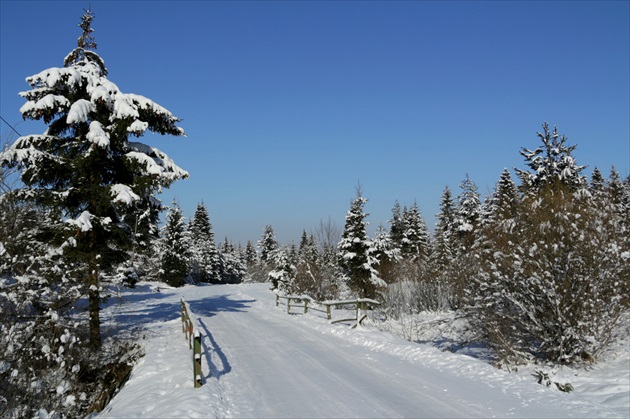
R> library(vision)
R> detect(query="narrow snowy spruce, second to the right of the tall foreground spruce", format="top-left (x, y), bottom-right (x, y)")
top-left (189, 202), bottom-right (220, 282)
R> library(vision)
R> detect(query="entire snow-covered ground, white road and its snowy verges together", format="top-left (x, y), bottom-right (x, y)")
top-left (96, 283), bottom-right (630, 418)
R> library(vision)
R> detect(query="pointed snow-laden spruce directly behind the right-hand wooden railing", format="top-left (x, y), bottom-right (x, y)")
top-left (337, 187), bottom-right (387, 298)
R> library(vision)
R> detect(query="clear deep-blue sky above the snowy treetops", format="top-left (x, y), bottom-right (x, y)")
top-left (0, 0), bottom-right (630, 245)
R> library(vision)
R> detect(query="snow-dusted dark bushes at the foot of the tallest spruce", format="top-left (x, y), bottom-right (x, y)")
top-left (0, 274), bottom-right (139, 418)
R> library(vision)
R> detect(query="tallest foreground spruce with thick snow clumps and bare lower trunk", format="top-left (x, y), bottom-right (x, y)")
top-left (0, 10), bottom-right (188, 348)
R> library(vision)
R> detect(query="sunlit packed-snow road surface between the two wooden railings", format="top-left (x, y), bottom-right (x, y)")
top-left (202, 296), bottom-right (478, 417)
